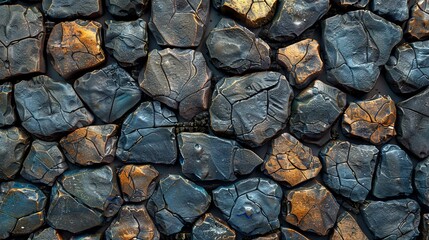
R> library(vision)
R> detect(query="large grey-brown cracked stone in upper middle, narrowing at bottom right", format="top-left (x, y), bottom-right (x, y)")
top-left (139, 48), bottom-right (211, 120)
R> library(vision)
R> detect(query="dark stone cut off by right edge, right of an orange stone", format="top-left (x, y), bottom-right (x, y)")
top-left (396, 88), bottom-right (429, 158)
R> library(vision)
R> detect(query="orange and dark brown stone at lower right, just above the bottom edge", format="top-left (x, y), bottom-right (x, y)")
top-left (284, 182), bottom-right (339, 236)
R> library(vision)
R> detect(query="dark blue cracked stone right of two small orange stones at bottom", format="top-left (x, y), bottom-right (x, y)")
top-left (147, 175), bottom-right (211, 235)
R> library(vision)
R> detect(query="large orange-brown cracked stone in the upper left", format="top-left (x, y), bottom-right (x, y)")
top-left (47, 19), bottom-right (106, 79)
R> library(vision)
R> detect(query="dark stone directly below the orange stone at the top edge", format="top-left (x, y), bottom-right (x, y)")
top-left (206, 18), bottom-right (271, 74)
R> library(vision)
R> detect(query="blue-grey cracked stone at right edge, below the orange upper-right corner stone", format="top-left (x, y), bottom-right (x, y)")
top-left (385, 41), bottom-right (429, 94)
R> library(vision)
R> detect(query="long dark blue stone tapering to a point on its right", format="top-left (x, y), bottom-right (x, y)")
top-left (177, 132), bottom-right (263, 181)
